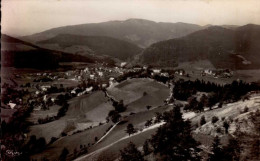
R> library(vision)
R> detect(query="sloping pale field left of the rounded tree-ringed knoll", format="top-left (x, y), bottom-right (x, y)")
top-left (29, 91), bottom-right (113, 142)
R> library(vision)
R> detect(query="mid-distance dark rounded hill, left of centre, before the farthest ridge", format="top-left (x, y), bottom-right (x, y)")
top-left (38, 34), bottom-right (141, 60)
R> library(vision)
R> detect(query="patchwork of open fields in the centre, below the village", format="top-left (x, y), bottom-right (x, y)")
top-left (30, 79), bottom-right (170, 159)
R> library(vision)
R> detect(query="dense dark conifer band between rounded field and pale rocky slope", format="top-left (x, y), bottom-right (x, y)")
top-left (173, 80), bottom-right (260, 112)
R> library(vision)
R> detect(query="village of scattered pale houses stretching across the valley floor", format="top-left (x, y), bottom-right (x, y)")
top-left (2, 62), bottom-right (236, 118)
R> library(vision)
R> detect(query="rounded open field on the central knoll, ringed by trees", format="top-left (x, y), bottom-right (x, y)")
top-left (108, 78), bottom-right (170, 112)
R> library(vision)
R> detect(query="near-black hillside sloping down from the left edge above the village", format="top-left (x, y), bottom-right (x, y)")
top-left (1, 34), bottom-right (100, 69)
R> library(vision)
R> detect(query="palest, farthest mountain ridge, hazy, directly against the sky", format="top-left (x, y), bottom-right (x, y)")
top-left (22, 19), bottom-right (202, 47)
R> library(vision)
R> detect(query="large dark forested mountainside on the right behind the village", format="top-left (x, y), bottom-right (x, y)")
top-left (141, 25), bottom-right (260, 69)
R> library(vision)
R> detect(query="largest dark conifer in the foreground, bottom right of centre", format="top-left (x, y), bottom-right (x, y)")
top-left (150, 107), bottom-right (200, 161)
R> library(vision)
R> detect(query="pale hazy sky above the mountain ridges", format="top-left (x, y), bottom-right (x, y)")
top-left (1, 0), bottom-right (260, 36)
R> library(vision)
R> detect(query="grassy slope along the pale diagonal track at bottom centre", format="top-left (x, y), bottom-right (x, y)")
top-left (76, 106), bottom-right (171, 160)
